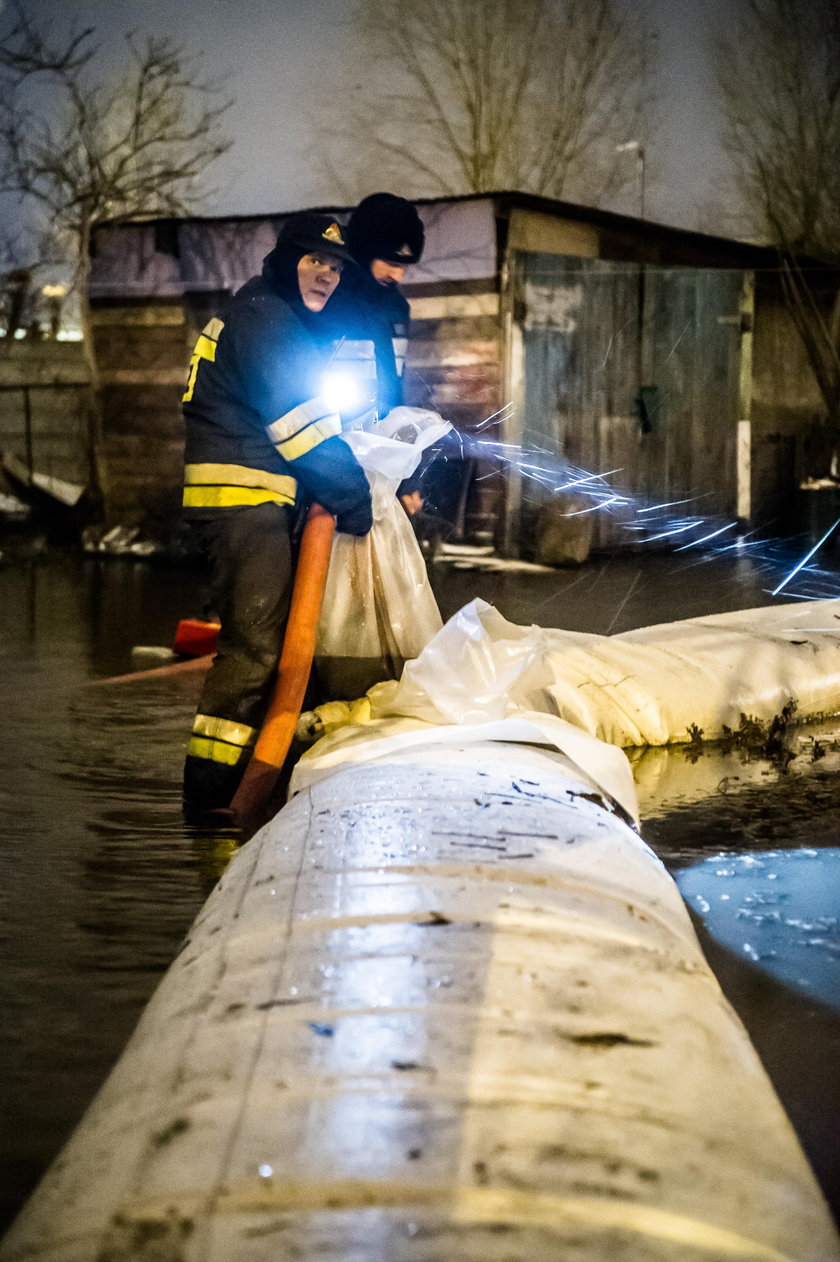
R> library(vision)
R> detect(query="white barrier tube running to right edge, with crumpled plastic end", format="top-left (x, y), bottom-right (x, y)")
top-left (370, 599), bottom-right (840, 747)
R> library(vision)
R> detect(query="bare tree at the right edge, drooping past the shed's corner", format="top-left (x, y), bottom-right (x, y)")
top-left (716, 0), bottom-right (840, 440)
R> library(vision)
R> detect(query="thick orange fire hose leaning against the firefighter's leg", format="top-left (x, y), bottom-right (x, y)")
top-left (230, 504), bottom-right (335, 839)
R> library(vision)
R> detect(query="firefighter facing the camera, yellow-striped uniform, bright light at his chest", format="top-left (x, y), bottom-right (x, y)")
top-left (183, 212), bottom-right (372, 813)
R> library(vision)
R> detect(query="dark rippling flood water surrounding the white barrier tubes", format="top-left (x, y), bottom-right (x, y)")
top-left (0, 548), bottom-right (840, 1225)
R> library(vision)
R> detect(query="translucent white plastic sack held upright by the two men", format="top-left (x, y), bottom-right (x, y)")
top-left (315, 408), bottom-right (452, 699)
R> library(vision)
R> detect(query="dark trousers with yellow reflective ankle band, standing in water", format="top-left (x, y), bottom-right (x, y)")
top-left (184, 504), bottom-right (294, 810)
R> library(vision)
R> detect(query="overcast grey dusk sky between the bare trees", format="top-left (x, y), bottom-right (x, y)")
top-left (6, 0), bottom-right (738, 231)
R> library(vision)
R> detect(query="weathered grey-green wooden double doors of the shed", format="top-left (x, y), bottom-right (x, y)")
top-left (508, 252), bottom-right (743, 555)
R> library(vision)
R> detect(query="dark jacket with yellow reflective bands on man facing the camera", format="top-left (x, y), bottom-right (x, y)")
top-left (183, 255), bottom-right (371, 534)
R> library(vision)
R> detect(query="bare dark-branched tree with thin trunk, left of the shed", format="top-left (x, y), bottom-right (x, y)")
top-left (0, 0), bottom-right (230, 507)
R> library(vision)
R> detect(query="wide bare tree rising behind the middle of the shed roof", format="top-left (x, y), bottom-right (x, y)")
top-left (310, 0), bottom-right (650, 203)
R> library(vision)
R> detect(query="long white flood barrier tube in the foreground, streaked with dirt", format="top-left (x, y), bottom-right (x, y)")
top-left (0, 742), bottom-right (840, 1262)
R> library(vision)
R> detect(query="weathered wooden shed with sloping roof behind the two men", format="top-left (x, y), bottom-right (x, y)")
top-left (91, 193), bottom-right (825, 557)
